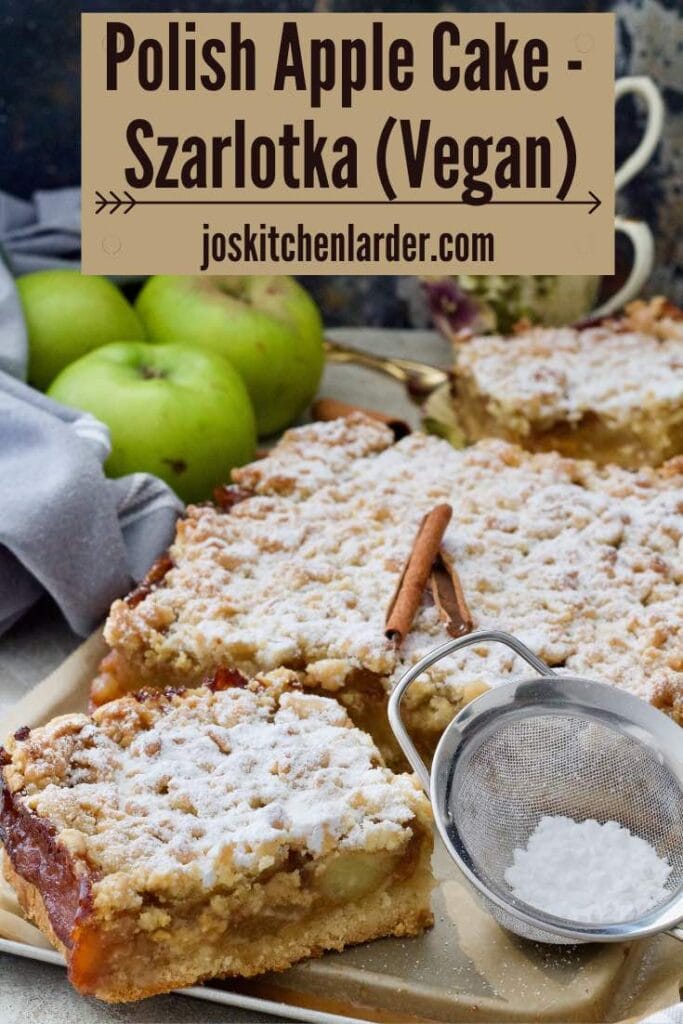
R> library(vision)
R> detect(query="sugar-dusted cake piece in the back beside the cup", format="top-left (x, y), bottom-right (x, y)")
top-left (453, 299), bottom-right (683, 469)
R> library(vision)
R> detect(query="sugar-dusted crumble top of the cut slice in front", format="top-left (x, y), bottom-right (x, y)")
top-left (11, 672), bottom-right (427, 894)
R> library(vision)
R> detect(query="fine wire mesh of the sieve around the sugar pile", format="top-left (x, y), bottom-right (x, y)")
top-left (447, 708), bottom-right (683, 942)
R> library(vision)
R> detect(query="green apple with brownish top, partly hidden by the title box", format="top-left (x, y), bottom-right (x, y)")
top-left (135, 275), bottom-right (325, 435)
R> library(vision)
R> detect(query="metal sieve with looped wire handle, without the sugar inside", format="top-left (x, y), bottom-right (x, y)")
top-left (389, 631), bottom-right (683, 943)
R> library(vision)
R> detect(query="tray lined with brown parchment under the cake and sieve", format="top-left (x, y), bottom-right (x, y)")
top-left (0, 633), bottom-right (683, 1024)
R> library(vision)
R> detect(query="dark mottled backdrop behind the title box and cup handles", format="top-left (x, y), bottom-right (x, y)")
top-left (0, 0), bottom-right (683, 325)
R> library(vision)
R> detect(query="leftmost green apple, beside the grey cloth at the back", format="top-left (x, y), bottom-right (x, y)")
top-left (16, 270), bottom-right (144, 391)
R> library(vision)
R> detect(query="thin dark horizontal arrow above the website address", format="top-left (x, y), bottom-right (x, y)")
top-left (95, 188), bottom-right (602, 216)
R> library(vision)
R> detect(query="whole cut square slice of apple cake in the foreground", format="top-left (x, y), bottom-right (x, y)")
top-left (0, 670), bottom-right (432, 1001)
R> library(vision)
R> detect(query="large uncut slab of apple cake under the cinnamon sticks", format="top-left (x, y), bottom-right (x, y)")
top-left (92, 415), bottom-right (683, 758)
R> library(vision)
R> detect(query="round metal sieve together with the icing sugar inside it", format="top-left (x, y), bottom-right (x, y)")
top-left (389, 631), bottom-right (683, 944)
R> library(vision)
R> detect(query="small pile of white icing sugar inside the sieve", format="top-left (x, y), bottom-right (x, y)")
top-left (505, 815), bottom-right (672, 925)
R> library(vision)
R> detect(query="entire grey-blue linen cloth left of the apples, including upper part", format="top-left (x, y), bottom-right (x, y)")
top-left (0, 189), bottom-right (182, 636)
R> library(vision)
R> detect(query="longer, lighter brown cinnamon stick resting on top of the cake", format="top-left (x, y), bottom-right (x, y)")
top-left (384, 504), bottom-right (453, 645)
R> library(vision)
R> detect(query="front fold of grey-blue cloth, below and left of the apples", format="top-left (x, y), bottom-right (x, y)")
top-left (0, 373), bottom-right (182, 636)
